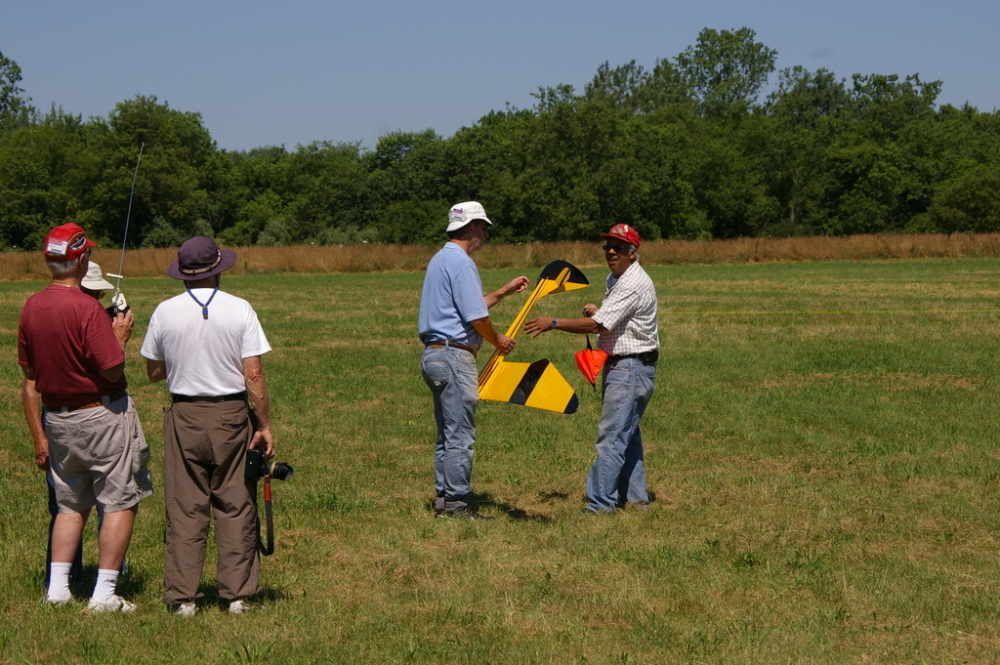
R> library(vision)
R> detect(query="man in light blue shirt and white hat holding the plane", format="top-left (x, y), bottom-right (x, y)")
top-left (418, 201), bottom-right (529, 519)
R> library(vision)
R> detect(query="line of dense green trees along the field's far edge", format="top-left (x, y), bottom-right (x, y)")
top-left (0, 27), bottom-right (1000, 250)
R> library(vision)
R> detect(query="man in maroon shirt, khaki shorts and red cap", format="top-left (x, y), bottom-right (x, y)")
top-left (17, 224), bottom-right (153, 612)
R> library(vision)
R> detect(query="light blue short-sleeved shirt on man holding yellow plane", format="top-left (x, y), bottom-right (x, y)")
top-left (417, 241), bottom-right (489, 349)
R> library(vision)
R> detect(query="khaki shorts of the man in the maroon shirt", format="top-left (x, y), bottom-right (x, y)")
top-left (45, 395), bottom-right (153, 513)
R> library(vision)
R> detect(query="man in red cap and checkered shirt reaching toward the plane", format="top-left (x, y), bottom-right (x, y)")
top-left (524, 224), bottom-right (660, 513)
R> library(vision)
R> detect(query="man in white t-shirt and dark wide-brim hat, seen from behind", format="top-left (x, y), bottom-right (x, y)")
top-left (142, 236), bottom-right (274, 617)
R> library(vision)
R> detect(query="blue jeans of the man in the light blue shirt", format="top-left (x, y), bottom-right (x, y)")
top-left (420, 346), bottom-right (479, 510)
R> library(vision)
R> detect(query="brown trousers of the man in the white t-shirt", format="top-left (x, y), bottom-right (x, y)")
top-left (163, 401), bottom-right (260, 605)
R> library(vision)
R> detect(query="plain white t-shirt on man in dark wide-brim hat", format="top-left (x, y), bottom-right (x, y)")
top-left (141, 289), bottom-right (271, 397)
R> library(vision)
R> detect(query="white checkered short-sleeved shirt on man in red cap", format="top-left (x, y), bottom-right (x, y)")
top-left (592, 263), bottom-right (660, 356)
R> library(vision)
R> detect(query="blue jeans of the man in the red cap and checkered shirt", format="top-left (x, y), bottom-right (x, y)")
top-left (587, 358), bottom-right (656, 513)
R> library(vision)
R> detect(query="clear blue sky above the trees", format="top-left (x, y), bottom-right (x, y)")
top-left (0, 0), bottom-right (1000, 150)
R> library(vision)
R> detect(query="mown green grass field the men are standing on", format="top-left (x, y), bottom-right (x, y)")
top-left (0, 257), bottom-right (1000, 665)
